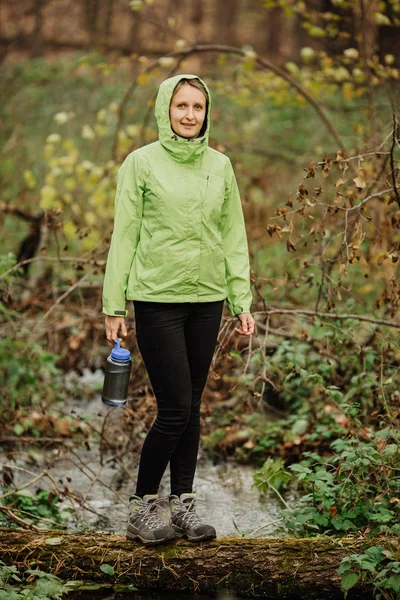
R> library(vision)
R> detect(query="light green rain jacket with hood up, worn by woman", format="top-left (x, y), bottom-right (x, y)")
top-left (103, 75), bottom-right (252, 316)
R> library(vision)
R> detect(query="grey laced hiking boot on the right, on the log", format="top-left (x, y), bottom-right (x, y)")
top-left (169, 493), bottom-right (217, 542)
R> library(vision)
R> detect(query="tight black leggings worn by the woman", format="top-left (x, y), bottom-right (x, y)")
top-left (133, 300), bottom-right (224, 497)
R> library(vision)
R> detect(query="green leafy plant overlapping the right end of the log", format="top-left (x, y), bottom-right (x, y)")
top-left (338, 546), bottom-right (400, 600)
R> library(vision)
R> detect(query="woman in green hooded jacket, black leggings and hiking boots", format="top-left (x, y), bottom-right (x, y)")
top-left (103, 75), bottom-right (254, 544)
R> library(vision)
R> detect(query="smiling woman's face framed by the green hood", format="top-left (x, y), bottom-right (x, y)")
top-left (169, 83), bottom-right (206, 138)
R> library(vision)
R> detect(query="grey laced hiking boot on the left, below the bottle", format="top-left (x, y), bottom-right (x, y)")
top-left (126, 494), bottom-right (176, 546)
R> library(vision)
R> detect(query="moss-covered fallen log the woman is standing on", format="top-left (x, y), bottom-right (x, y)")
top-left (0, 528), bottom-right (400, 600)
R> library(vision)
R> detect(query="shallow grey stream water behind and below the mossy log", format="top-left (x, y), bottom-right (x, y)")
top-left (3, 371), bottom-right (290, 600)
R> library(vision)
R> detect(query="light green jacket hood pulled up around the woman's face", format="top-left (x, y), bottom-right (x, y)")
top-left (155, 74), bottom-right (211, 163)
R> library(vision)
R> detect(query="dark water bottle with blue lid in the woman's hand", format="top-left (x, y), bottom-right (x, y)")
top-left (101, 338), bottom-right (132, 407)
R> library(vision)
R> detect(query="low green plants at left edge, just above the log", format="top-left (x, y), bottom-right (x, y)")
top-left (1, 488), bottom-right (74, 529)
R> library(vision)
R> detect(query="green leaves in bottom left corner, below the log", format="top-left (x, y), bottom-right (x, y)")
top-left (0, 560), bottom-right (68, 600)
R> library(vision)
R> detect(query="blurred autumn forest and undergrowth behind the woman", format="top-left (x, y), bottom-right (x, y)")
top-left (0, 0), bottom-right (400, 597)
